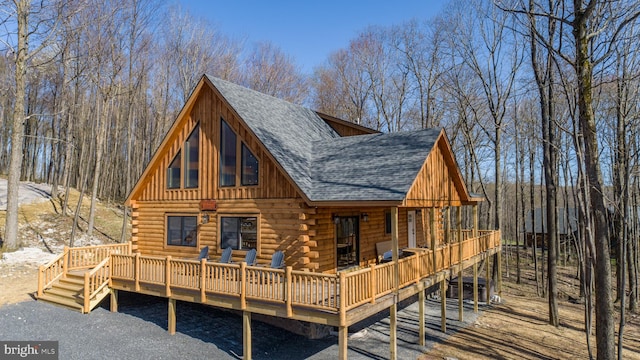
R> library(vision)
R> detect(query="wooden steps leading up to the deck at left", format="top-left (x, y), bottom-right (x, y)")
top-left (38, 270), bottom-right (111, 313)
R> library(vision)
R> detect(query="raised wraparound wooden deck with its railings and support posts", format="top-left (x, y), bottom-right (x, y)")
top-left (38, 230), bottom-right (501, 356)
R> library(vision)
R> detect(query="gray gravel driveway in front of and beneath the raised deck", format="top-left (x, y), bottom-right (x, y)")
top-left (0, 291), bottom-right (477, 360)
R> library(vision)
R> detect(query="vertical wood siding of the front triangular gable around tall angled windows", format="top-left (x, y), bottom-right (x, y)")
top-left (131, 86), bottom-right (299, 202)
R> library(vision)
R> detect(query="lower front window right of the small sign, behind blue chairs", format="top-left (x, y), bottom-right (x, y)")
top-left (220, 216), bottom-right (258, 250)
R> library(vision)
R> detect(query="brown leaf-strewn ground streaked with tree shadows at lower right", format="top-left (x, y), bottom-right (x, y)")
top-left (421, 262), bottom-right (640, 360)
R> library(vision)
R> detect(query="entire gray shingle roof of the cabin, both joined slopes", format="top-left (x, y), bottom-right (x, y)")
top-left (207, 76), bottom-right (440, 201)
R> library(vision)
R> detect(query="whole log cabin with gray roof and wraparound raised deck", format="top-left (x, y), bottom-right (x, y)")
top-left (38, 75), bottom-right (500, 358)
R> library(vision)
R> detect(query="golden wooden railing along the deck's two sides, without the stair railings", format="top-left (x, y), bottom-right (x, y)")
top-left (110, 231), bottom-right (500, 316)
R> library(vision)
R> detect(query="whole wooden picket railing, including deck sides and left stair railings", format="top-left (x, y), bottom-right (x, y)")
top-left (38, 231), bottom-right (500, 322)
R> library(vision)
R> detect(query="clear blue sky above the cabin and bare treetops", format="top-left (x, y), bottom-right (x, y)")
top-left (178, 0), bottom-right (448, 73)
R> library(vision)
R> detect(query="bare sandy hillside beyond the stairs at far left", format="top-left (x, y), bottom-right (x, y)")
top-left (0, 179), bottom-right (130, 306)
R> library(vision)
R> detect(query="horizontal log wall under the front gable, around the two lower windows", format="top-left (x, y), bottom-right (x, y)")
top-left (132, 199), bottom-right (319, 269)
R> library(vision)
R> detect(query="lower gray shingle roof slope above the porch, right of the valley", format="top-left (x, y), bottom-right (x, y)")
top-left (312, 129), bottom-right (440, 201)
